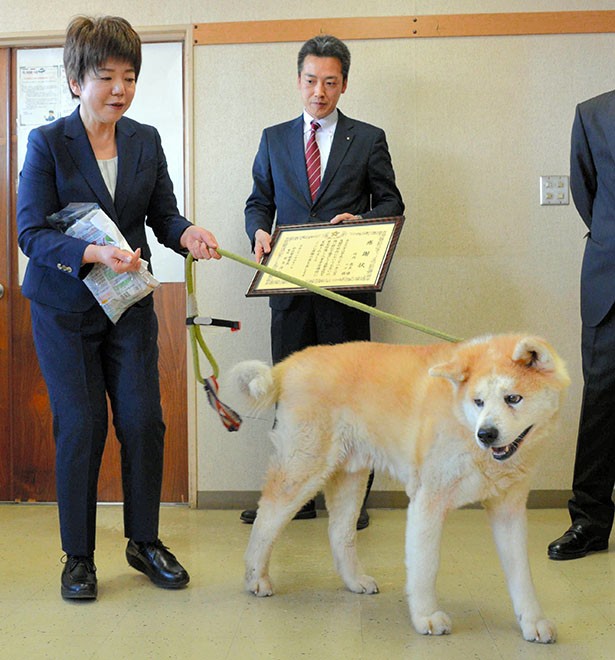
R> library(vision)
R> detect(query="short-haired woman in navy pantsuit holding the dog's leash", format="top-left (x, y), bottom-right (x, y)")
top-left (17, 17), bottom-right (219, 599)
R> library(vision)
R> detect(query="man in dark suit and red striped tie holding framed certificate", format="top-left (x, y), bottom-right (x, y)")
top-left (241, 35), bottom-right (404, 529)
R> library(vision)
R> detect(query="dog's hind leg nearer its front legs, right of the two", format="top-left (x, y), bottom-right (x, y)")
top-left (324, 470), bottom-right (378, 594)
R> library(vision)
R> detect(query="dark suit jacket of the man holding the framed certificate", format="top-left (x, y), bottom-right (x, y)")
top-left (245, 110), bottom-right (404, 309)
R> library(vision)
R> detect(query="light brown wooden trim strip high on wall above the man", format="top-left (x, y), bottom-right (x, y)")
top-left (193, 10), bottom-right (615, 46)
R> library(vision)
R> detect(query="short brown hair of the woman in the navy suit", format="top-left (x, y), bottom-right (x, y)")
top-left (64, 16), bottom-right (141, 98)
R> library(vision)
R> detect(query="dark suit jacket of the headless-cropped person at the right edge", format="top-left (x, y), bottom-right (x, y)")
top-left (570, 91), bottom-right (615, 327)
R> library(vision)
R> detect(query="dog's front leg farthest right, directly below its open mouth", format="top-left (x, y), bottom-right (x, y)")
top-left (485, 499), bottom-right (557, 644)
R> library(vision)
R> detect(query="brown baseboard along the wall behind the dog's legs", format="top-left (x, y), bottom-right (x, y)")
top-left (197, 490), bottom-right (572, 509)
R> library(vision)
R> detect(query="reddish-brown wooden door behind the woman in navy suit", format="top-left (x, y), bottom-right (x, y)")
top-left (0, 45), bottom-right (188, 502)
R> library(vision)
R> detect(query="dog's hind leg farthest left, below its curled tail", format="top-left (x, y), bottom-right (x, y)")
top-left (245, 458), bottom-right (325, 596)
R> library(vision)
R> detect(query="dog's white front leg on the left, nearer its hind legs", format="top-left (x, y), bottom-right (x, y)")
top-left (406, 488), bottom-right (452, 635)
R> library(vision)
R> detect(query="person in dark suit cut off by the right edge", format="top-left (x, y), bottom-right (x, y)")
top-left (548, 92), bottom-right (615, 559)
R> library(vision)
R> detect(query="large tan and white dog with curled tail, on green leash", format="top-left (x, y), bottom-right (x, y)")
top-left (231, 335), bottom-right (569, 642)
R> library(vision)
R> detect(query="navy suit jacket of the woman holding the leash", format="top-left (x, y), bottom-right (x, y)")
top-left (17, 108), bottom-right (190, 312)
